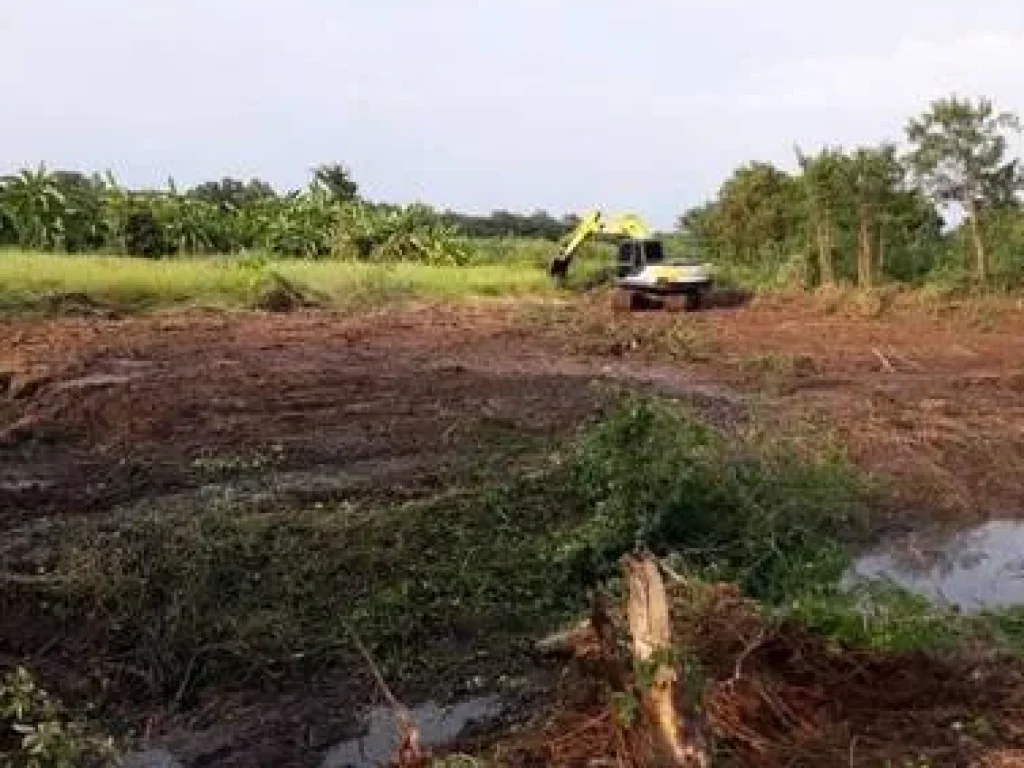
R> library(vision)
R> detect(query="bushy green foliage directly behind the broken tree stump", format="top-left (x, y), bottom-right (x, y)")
top-left (563, 398), bottom-right (862, 599)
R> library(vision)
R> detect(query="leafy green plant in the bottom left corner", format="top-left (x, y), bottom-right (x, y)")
top-left (0, 667), bottom-right (117, 768)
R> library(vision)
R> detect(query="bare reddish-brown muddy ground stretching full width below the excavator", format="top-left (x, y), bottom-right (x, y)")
top-left (0, 300), bottom-right (1024, 765)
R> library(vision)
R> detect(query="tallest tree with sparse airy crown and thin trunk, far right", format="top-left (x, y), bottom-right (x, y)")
top-left (906, 95), bottom-right (1024, 282)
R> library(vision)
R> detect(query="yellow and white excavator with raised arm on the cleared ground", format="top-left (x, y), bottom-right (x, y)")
top-left (549, 211), bottom-right (712, 311)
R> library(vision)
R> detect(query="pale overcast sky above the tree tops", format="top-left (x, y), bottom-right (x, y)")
top-left (0, 0), bottom-right (1024, 225)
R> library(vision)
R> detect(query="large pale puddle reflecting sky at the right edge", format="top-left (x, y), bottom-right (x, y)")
top-left (855, 520), bottom-right (1024, 612)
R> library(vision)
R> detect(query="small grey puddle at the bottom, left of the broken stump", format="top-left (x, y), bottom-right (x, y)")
top-left (323, 696), bottom-right (504, 768)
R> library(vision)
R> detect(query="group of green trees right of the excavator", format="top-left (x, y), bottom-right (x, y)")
top-left (679, 95), bottom-right (1024, 287)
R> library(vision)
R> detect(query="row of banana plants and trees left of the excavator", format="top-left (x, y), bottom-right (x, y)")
top-left (0, 164), bottom-right (575, 258)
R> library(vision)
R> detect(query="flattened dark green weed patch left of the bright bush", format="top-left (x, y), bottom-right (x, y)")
top-left (10, 467), bottom-right (593, 702)
